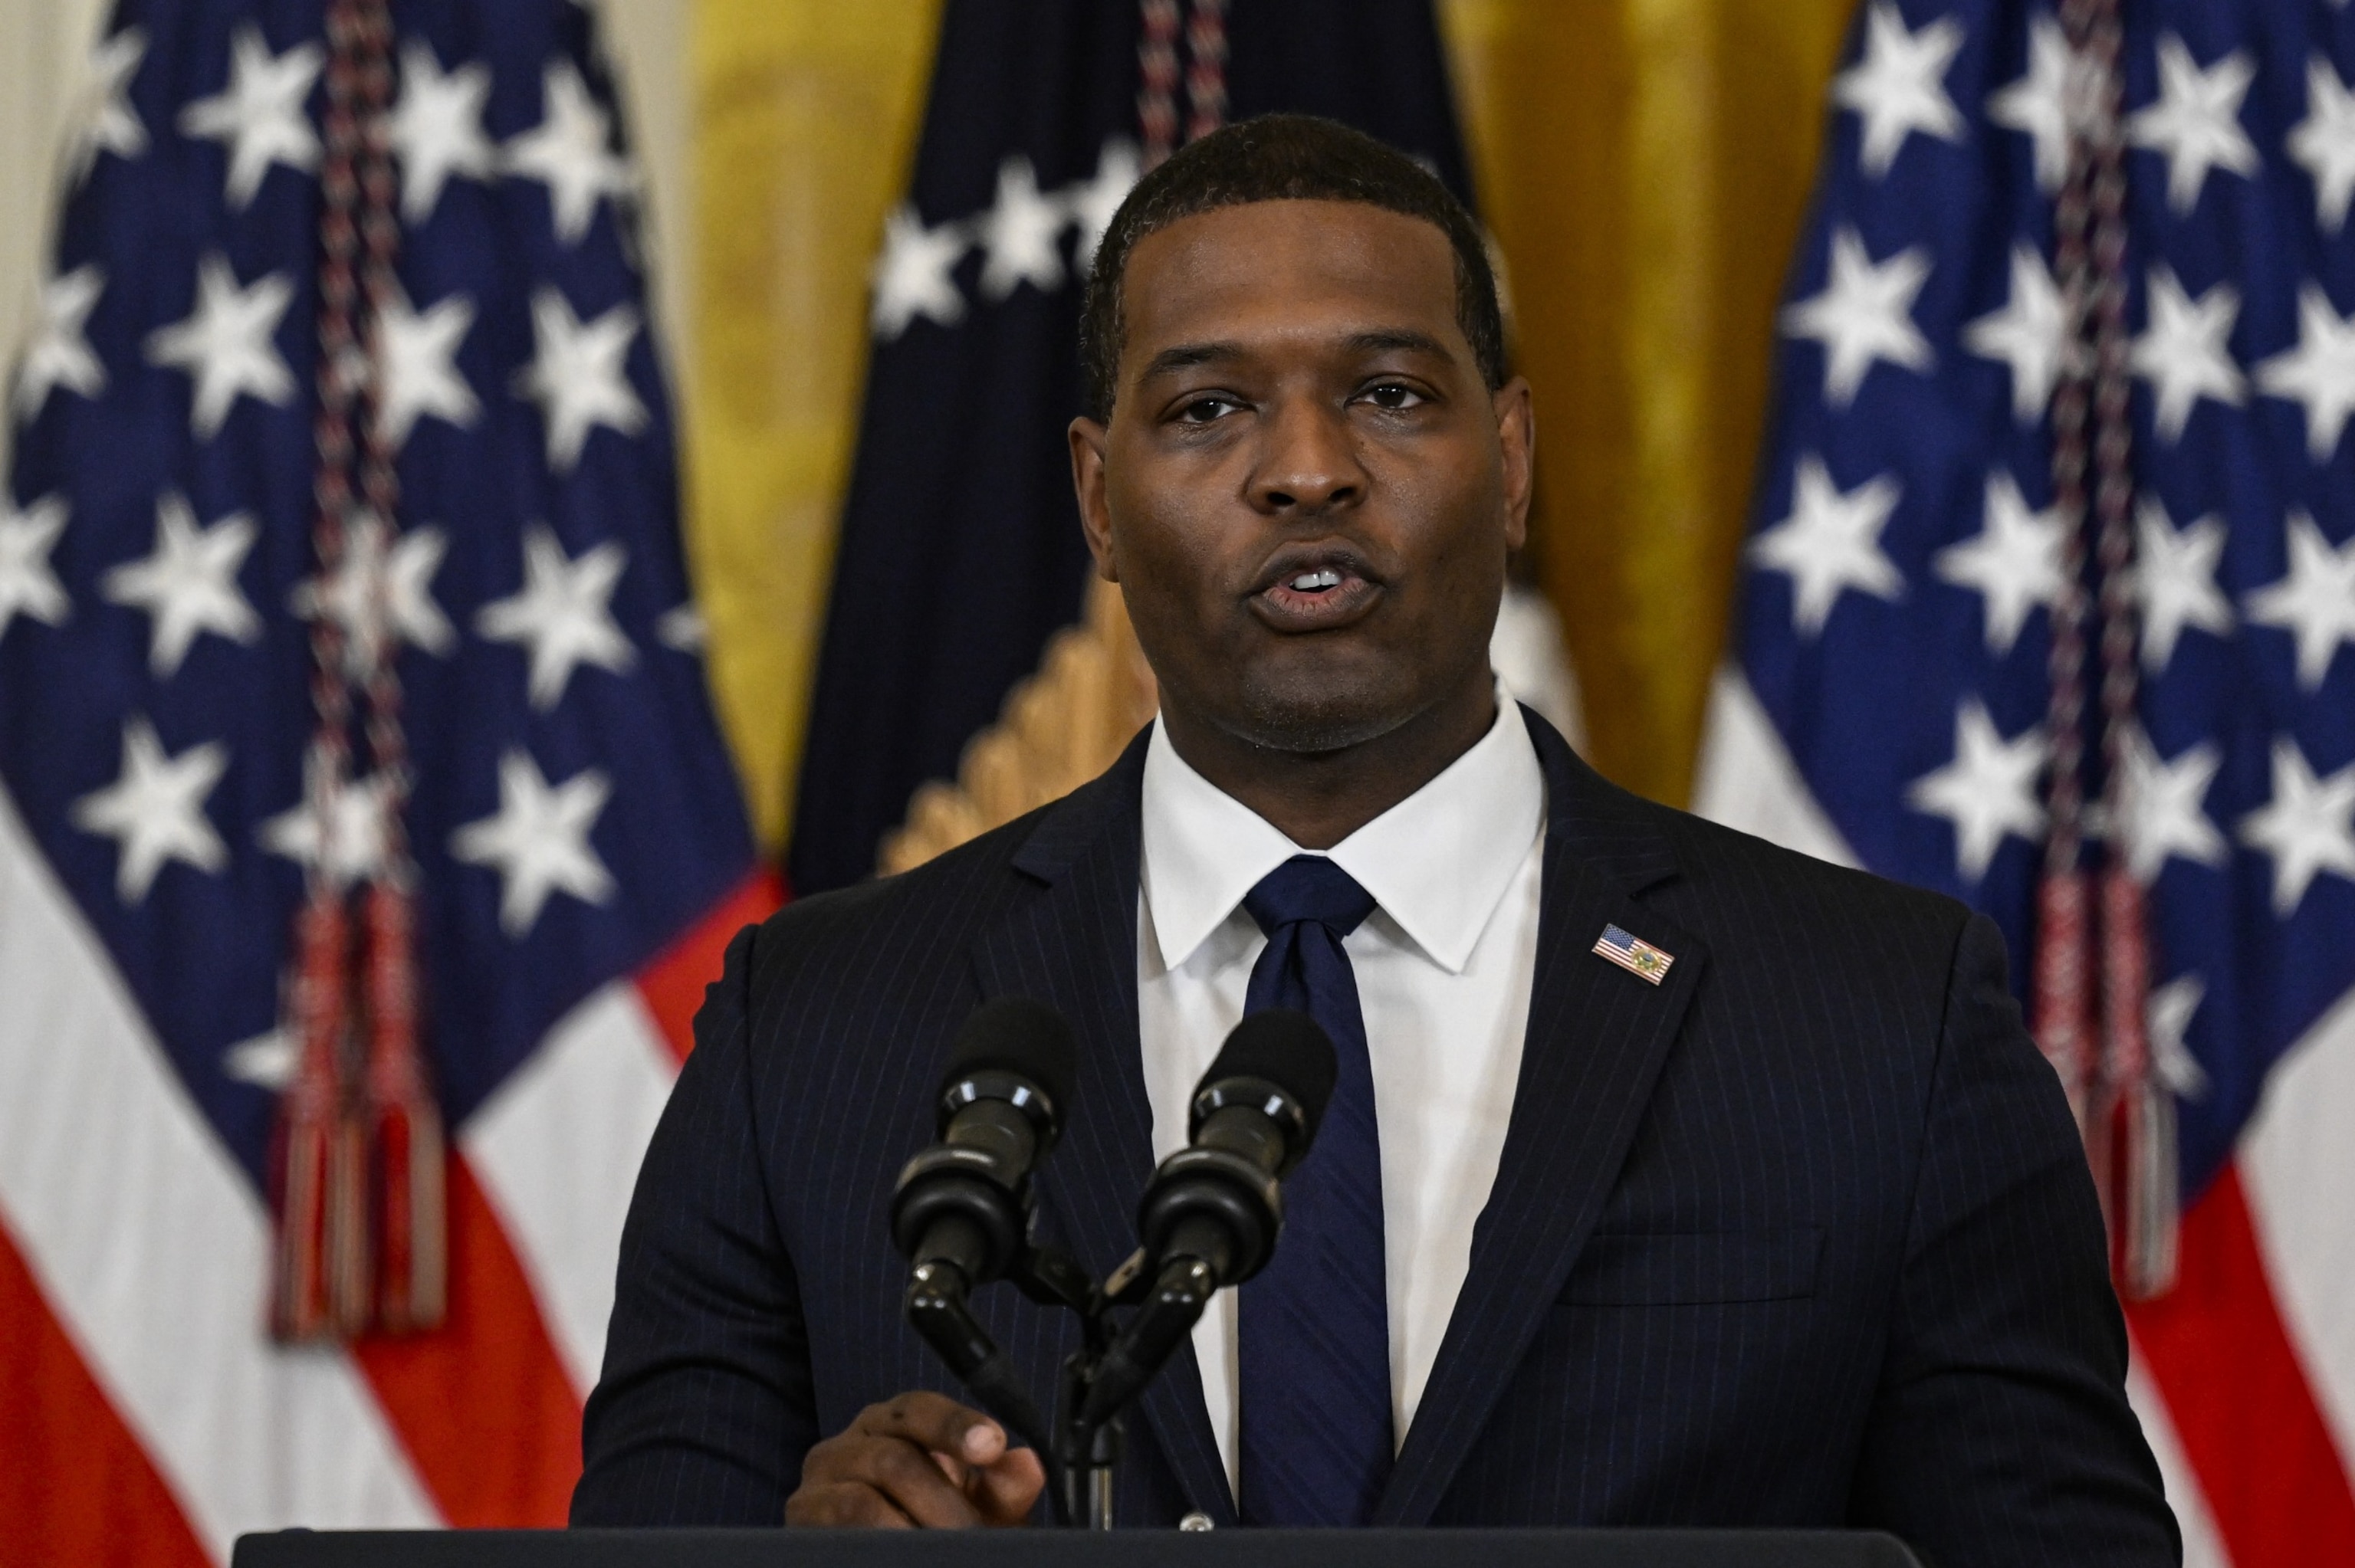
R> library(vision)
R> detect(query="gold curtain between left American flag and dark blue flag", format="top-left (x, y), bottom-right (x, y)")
top-left (681, 0), bottom-right (940, 848)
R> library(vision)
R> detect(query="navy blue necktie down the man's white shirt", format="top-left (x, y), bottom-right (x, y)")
top-left (1237, 855), bottom-right (1394, 1526)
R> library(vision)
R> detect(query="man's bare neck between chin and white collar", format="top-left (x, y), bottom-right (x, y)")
top-left (1161, 668), bottom-right (1496, 850)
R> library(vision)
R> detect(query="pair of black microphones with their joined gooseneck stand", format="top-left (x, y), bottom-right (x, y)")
top-left (892, 1001), bottom-right (1335, 1530)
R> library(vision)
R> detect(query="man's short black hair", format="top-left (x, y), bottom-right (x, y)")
top-left (1079, 116), bottom-right (1505, 419)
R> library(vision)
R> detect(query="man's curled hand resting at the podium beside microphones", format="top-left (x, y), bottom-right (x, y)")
top-left (784, 1394), bottom-right (1046, 1530)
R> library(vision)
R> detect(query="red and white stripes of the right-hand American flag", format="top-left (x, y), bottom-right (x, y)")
top-left (1693, 668), bottom-right (2355, 1568)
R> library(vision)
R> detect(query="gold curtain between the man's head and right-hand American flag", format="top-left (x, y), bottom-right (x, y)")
top-left (1439, 0), bottom-right (1854, 803)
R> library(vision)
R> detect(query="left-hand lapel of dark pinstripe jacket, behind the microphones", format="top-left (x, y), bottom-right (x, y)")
top-left (975, 734), bottom-right (1237, 1526)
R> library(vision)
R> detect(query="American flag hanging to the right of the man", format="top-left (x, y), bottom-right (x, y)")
top-left (1700, 0), bottom-right (2355, 1568)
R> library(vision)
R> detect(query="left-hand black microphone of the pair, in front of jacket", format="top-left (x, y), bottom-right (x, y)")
top-left (890, 996), bottom-right (1079, 1290)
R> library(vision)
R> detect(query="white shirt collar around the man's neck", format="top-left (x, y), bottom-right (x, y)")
top-left (1142, 683), bottom-right (1545, 975)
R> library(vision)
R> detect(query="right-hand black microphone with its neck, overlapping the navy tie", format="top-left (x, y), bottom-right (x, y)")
top-left (1081, 1008), bottom-right (1340, 1427)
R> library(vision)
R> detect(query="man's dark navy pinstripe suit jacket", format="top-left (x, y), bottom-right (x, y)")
top-left (572, 716), bottom-right (2179, 1566)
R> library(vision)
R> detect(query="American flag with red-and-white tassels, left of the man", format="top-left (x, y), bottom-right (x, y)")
top-left (0, 0), bottom-right (773, 1561)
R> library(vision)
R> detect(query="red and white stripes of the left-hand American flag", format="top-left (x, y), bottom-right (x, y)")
top-left (0, 791), bottom-right (777, 1563)
